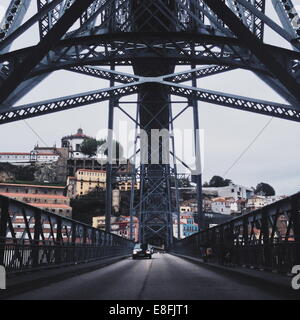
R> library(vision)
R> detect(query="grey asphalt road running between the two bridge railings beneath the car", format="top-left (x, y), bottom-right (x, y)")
top-left (6, 254), bottom-right (296, 300)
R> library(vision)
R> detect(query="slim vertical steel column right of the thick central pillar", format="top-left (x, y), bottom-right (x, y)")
top-left (191, 65), bottom-right (205, 231)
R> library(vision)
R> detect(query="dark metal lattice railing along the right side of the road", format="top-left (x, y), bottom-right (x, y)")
top-left (172, 193), bottom-right (300, 273)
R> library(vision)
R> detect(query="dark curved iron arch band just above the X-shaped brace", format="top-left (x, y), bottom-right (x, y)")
top-left (0, 33), bottom-right (300, 77)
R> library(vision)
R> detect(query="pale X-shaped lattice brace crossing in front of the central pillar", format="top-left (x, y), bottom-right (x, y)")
top-left (0, 67), bottom-right (300, 124)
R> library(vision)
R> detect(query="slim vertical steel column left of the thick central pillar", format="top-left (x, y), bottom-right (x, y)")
top-left (105, 65), bottom-right (115, 232)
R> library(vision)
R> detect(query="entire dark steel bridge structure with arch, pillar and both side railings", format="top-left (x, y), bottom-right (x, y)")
top-left (0, 0), bottom-right (300, 300)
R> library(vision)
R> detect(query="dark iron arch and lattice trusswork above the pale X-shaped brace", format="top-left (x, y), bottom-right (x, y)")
top-left (0, 0), bottom-right (300, 104)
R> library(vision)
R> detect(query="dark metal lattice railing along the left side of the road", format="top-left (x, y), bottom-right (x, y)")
top-left (0, 196), bottom-right (133, 273)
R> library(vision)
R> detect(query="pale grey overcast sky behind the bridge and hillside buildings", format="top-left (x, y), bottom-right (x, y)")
top-left (0, 0), bottom-right (300, 194)
